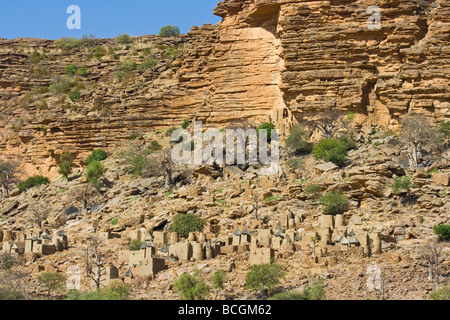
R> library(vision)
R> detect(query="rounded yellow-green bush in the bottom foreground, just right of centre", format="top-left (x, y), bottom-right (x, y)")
top-left (245, 263), bottom-right (286, 295)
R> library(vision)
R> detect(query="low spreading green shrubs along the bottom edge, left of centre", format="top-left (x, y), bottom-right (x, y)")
top-left (66, 281), bottom-right (131, 301)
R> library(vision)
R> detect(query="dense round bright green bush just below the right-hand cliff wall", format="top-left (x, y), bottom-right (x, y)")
top-left (312, 138), bottom-right (348, 166)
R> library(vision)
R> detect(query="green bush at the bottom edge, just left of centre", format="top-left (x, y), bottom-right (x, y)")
top-left (172, 270), bottom-right (210, 300)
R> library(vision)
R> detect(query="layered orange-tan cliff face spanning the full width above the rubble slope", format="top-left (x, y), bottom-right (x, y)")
top-left (0, 0), bottom-right (450, 177)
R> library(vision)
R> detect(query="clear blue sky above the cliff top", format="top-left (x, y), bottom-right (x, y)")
top-left (0, 0), bottom-right (221, 39)
